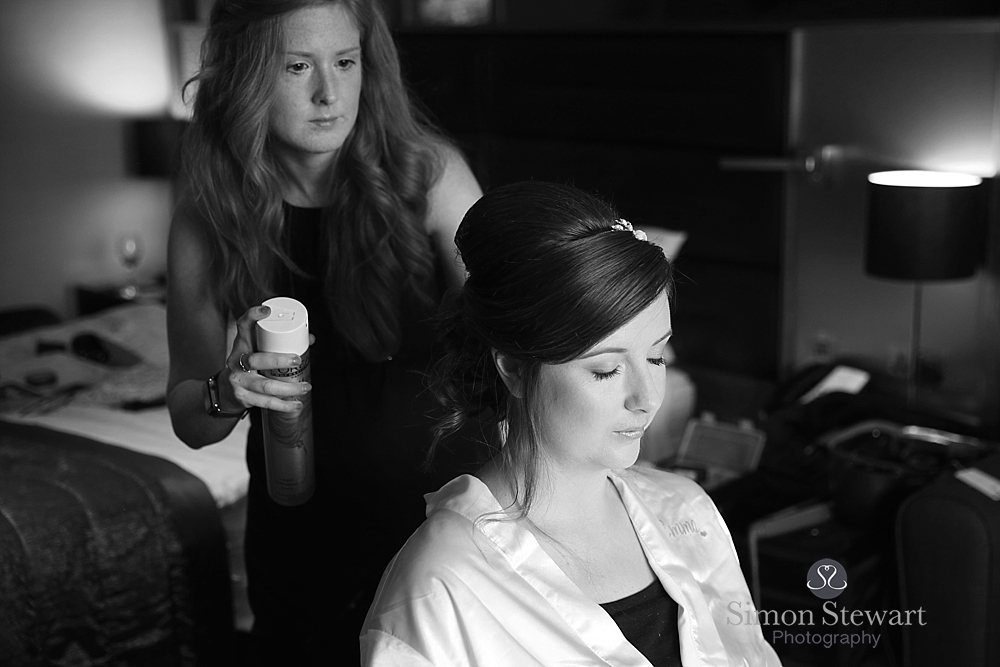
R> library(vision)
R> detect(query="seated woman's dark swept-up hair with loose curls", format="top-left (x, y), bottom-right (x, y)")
top-left (432, 182), bottom-right (673, 514)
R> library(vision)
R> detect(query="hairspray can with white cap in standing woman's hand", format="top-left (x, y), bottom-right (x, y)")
top-left (257, 296), bottom-right (316, 506)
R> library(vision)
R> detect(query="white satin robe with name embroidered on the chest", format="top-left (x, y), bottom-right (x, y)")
top-left (361, 467), bottom-right (780, 667)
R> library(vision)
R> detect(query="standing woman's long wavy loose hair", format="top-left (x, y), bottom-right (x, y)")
top-left (181, 0), bottom-right (446, 360)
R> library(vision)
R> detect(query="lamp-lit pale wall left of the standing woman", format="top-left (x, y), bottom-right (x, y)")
top-left (0, 0), bottom-right (171, 316)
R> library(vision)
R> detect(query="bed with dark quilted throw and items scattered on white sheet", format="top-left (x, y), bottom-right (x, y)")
top-left (0, 304), bottom-right (249, 665)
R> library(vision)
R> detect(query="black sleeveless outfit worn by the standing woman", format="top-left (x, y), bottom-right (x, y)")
top-left (238, 204), bottom-right (479, 646)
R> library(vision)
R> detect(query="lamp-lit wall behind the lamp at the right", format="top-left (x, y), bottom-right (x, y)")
top-left (784, 21), bottom-right (1000, 426)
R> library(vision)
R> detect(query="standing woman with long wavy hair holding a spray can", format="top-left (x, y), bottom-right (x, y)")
top-left (168, 0), bottom-right (481, 664)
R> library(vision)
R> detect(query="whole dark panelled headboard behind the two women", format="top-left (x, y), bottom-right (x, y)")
top-left (396, 31), bottom-right (788, 380)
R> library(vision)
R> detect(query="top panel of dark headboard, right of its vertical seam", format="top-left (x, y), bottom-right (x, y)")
top-left (492, 35), bottom-right (785, 150)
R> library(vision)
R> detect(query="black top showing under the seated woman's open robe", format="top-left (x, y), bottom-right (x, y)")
top-left (601, 579), bottom-right (681, 667)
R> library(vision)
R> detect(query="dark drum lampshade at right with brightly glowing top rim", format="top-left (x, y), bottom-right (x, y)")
top-left (865, 171), bottom-right (987, 280)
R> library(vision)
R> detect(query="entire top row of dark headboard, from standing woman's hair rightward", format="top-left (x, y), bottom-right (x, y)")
top-left (398, 33), bottom-right (787, 152)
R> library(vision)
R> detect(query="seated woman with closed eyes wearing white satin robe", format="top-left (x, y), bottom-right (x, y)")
top-left (360, 182), bottom-right (780, 667)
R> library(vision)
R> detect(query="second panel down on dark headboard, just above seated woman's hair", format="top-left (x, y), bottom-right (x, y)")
top-left (464, 136), bottom-right (782, 272)
